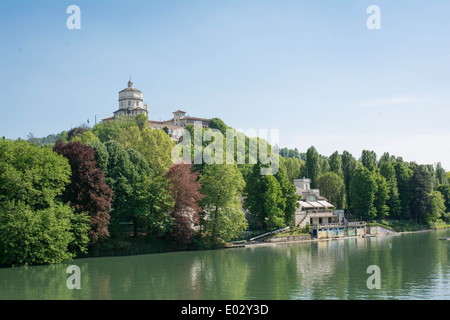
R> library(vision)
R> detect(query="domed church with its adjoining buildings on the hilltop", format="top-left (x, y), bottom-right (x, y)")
top-left (102, 78), bottom-right (209, 136)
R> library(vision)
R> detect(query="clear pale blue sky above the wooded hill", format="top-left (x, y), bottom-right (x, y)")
top-left (0, 0), bottom-right (450, 171)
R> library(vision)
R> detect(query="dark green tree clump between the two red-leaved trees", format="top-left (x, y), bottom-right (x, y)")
top-left (96, 141), bottom-right (173, 236)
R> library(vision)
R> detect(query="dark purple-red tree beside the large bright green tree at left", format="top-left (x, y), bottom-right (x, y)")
top-left (53, 142), bottom-right (114, 244)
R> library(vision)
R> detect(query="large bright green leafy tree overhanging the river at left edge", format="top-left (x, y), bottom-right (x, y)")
top-left (0, 139), bottom-right (89, 265)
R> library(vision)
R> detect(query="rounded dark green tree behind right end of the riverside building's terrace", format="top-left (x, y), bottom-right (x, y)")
top-left (350, 166), bottom-right (377, 220)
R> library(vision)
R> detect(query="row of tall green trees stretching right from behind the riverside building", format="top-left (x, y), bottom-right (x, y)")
top-left (285, 147), bottom-right (450, 224)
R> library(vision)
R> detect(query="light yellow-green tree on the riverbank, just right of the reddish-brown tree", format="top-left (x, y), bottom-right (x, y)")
top-left (200, 164), bottom-right (247, 243)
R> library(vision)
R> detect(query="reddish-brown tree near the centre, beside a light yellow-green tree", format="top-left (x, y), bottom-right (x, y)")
top-left (166, 163), bottom-right (203, 244)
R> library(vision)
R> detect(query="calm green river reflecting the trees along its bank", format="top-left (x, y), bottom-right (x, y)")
top-left (0, 229), bottom-right (450, 300)
